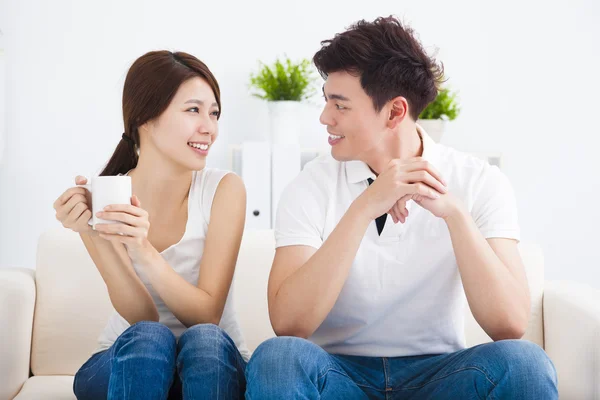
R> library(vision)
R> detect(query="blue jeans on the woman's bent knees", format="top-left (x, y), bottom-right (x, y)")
top-left (73, 322), bottom-right (246, 400)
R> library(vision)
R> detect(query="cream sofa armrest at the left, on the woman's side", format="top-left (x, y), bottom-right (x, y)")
top-left (0, 268), bottom-right (35, 399)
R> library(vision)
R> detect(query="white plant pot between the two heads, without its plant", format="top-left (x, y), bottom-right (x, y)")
top-left (268, 100), bottom-right (302, 145)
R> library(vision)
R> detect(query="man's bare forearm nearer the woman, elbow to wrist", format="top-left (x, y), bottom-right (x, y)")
top-left (270, 202), bottom-right (371, 338)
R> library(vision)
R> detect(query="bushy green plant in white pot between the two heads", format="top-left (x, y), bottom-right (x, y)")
top-left (250, 56), bottom-right (317, 144)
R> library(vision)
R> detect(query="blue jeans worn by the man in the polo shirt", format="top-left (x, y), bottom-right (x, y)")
top-left (246, 337), bottom-right (558, 400)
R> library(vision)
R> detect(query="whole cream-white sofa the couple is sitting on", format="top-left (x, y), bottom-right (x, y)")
top-left (0, 228), bottom-right (600, 400)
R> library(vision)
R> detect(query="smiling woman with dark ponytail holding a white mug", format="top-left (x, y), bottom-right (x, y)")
top-left (54, 51), bottom-right (248, 399)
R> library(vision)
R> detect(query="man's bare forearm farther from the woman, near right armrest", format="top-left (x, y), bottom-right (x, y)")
top-left (445, 209), bottom-right (529, 340)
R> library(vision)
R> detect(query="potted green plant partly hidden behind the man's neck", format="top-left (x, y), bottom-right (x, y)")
top-left (417, 88), bottom-right (460, 142)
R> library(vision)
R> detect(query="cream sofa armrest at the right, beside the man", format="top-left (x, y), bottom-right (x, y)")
top-left (543, 281), bottom-right (600, 400)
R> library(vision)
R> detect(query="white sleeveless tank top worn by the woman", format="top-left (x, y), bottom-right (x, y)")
top-left (95, 168), bottom-right (250, 361)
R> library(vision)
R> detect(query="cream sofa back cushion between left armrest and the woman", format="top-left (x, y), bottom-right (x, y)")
top-left (31, 228), bottom-right (113, 375)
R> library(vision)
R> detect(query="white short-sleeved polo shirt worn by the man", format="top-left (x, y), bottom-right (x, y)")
top-left (275, 127), bottom-right (519, 357)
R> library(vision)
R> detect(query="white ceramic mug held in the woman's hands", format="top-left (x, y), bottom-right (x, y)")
top-left (78, 175), bottom-right (132, 229)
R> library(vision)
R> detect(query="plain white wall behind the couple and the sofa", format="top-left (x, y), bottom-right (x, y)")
top-left (0, 0), bottom-right (600, 287)
